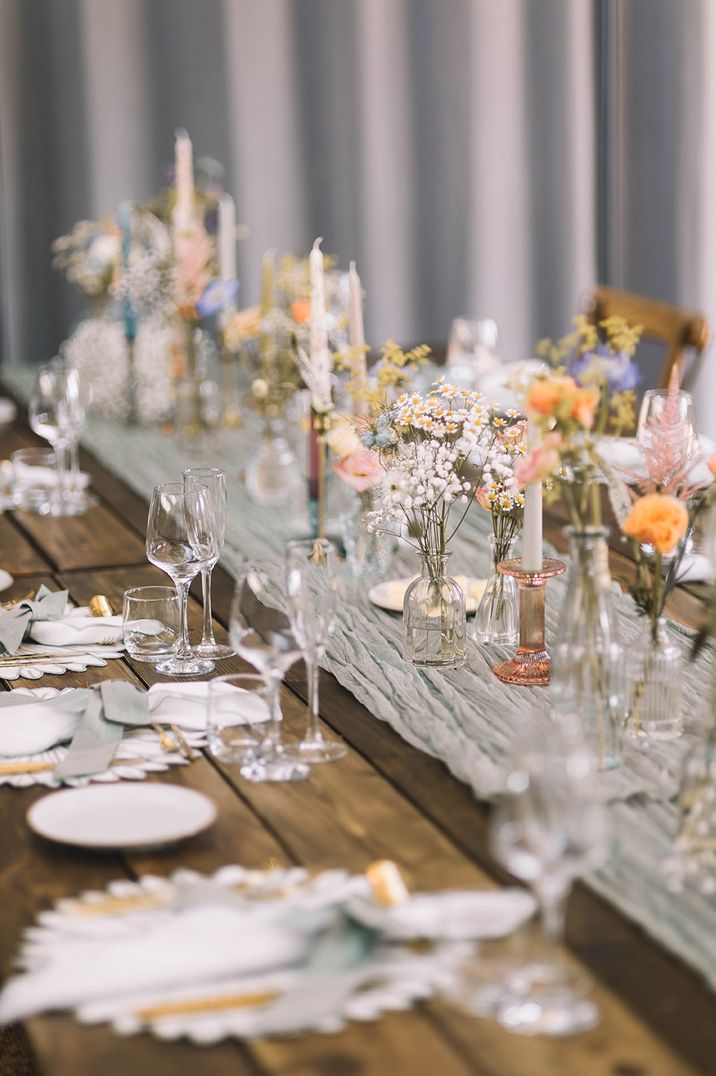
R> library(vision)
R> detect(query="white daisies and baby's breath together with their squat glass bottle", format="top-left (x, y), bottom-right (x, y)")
top-left (361, 381), bottom-right (503, 668)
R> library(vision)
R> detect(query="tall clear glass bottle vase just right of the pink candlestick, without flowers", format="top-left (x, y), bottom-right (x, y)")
top-left (550, 527), bottom-right (626, 769)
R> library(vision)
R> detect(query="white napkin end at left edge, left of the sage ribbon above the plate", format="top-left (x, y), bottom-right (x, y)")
top-left (0, 688), bottom-right (90, 756)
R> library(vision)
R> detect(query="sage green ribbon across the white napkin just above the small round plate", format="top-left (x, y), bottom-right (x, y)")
top-left (54, 680), bottom-right (149, 780)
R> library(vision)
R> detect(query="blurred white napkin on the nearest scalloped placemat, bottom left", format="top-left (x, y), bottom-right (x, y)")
top-left (0, 905), bottom-right (310, 1023)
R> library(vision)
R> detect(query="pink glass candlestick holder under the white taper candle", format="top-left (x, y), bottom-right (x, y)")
top-left (492, 558), bottom-right (566, 688)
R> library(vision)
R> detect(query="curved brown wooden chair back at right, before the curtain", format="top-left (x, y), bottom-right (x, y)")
top-left (586, 284), bottom-right (711, 388)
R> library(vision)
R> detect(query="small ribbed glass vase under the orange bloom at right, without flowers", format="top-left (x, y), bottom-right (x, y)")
top-left (626, 617), bottom-right (684, 740)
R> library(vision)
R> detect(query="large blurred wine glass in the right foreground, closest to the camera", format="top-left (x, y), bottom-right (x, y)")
top-left (491, 728), bottom-right (608, 1035)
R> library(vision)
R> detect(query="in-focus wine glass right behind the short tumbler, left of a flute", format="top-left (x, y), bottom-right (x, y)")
top-left (146, 482), bottom-right (219, 676)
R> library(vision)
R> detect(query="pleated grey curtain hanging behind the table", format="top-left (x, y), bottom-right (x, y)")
top-left (0, 0), bottom-right (716, 433)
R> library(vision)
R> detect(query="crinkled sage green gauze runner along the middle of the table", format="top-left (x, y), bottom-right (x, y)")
top-left (5, 365), bottom-right (716, 989)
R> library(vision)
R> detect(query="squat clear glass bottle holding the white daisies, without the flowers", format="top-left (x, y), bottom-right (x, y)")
top-left (403, 552), bottom-right (466, 668)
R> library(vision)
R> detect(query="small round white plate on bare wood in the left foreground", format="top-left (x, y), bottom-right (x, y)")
top-left (27, 784), bottom-right (216, 849)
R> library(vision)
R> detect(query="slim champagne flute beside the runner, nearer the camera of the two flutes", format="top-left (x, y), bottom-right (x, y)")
top-left (286, 538), bottom-right (348, 762)
